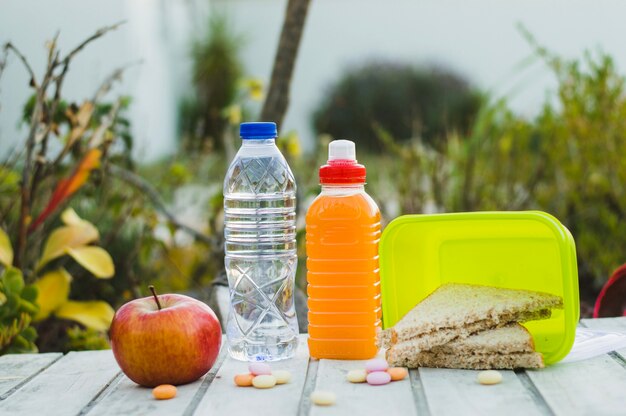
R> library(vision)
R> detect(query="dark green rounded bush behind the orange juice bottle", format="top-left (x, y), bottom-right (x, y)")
top-left (313, 63), bottom-right (481, 150)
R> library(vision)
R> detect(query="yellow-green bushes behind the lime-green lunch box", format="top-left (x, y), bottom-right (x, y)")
top-left (378, 48), bottom-right (626, 298)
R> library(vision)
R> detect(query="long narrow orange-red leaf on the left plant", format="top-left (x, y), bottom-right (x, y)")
top-left (28, 149), bottom-right (102, 231)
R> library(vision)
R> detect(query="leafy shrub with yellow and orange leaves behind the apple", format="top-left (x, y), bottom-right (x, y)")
top-left (0, 25), bottom-right (216, 354)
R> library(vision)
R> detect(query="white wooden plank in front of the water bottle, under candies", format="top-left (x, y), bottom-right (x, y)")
top-left (194, 336), bottom-right (309, 416)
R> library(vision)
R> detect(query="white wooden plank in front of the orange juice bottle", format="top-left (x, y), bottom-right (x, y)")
top-left (310, 360), bottom-right (417, 416)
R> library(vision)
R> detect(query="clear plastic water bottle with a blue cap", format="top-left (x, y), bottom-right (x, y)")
top-left (224, 123), bottom-right (298, 361)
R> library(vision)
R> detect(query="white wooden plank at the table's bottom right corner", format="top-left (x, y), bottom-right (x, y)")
top-left (526, 355), bottom-right (626, 415)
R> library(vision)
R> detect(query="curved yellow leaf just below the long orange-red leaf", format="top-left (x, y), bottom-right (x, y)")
top-left (37, 221), bottom-right (99, 269)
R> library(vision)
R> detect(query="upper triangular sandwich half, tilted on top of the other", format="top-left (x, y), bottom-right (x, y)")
top-left (381, 283), bottom-right (563, 352)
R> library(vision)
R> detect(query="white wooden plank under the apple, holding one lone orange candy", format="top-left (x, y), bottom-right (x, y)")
top-left (87, 346), bottom-right (225, 416)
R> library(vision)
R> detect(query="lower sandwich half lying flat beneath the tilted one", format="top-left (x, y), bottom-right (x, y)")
top-left (387, 323), bottom-right (543, 370)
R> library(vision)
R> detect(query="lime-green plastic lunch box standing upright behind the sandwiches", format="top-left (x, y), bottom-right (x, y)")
top-left (379, 211), bottom-right (580, 364)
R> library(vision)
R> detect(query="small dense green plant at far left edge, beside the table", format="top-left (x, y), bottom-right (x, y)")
top-left (0, 266), bottom-right (39, 355)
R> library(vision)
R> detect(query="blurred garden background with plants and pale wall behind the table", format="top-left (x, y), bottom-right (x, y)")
top-left (0, 0), bottom-right (626, 353)
